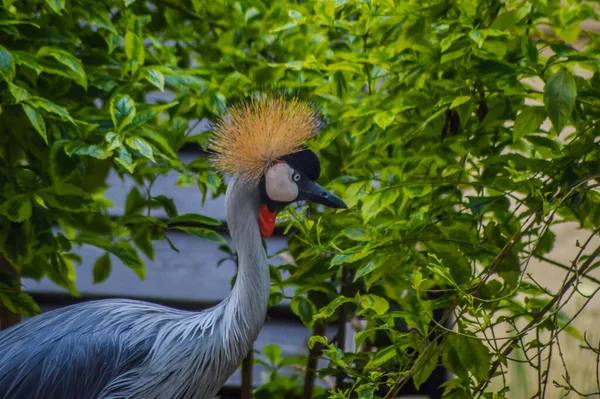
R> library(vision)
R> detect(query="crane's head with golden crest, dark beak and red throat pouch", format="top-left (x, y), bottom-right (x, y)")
top-left (211, 97), bottom-right (347, 238)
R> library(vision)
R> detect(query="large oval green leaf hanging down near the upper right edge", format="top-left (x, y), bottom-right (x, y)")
top-left (544, 68), bottom-right (577, 133)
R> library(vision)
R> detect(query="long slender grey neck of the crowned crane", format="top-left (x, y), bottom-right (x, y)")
top-left (218, 176), bottom-right (270, 361)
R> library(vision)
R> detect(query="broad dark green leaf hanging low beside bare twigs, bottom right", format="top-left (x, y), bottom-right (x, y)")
top-left (448, 334), bottom-right (492, 381)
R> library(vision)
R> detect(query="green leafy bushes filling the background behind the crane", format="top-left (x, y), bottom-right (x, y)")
top-left (0, 0), bottom-right (600, 398)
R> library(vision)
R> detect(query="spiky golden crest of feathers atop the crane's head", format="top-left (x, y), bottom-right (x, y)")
top-left (210, 97), bottom-right (320, 181)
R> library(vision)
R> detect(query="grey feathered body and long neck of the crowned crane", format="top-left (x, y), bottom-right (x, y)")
top-left (0, 178), bottom-right (269, 399)
